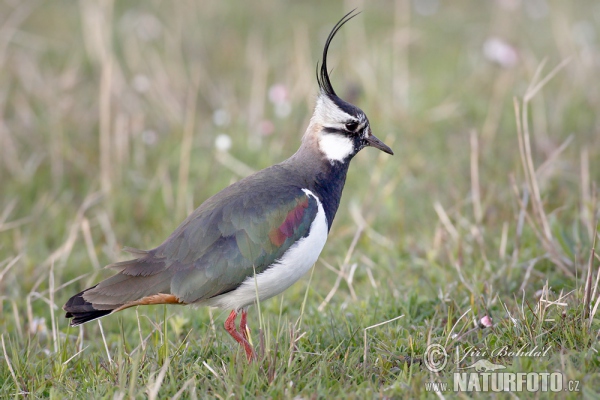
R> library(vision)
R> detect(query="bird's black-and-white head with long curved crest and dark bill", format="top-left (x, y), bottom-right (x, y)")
top-left (307, 11), bottom-right (394, 164)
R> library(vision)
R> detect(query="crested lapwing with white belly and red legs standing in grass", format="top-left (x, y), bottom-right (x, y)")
top-left (63, 10), bottom-right (394, 362)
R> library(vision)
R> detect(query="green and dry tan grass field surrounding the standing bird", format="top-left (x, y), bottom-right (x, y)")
top-left (0, 0), bottom-right (600, 399)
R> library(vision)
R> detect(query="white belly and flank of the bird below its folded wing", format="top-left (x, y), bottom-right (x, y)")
top-left (205, 189), bottom-right (328, 310)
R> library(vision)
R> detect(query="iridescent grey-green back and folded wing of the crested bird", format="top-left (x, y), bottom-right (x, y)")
top-left (82, 166), bottom-right (318, 309)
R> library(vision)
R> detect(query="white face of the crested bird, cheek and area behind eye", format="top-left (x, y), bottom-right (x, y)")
top-left (311, 96), bottom-right (366, 163)
